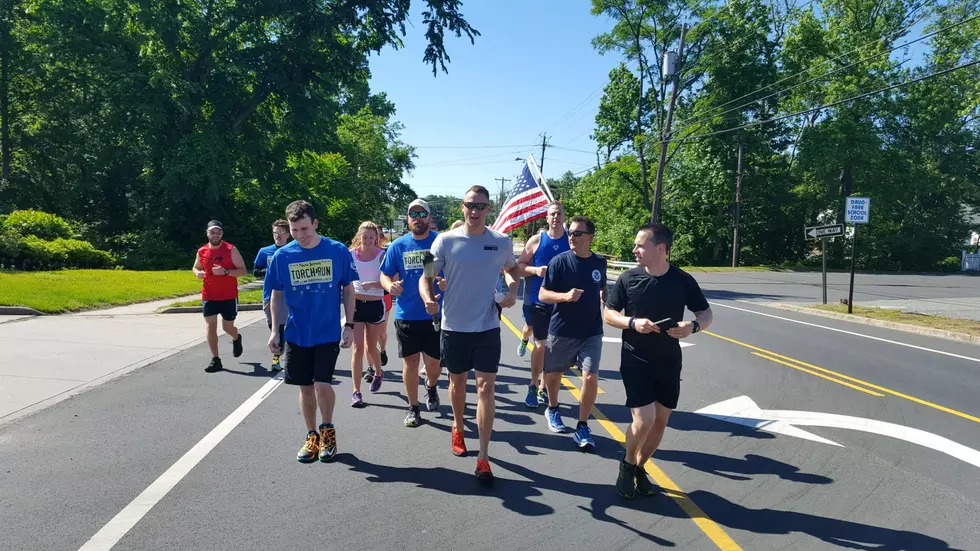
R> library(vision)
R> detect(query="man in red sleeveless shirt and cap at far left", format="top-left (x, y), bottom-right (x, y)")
top-left (192, 220), bottom-right (248, 373)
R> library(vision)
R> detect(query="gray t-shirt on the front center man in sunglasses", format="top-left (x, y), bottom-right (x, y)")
top-left (431, 227), bottom-right (517, 333)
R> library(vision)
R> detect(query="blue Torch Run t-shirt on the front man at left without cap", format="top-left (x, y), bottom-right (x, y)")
top-left (265, 237), bottom-right (357, 347)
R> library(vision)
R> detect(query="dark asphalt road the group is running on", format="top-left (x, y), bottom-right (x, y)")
top-left (0, 274), bottom-right (980, 550)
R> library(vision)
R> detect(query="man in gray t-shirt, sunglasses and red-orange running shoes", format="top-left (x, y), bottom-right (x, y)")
top-left (419, 186), bottom-right (521, 480)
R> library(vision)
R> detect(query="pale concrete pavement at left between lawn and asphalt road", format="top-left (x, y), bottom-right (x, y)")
top-left (0, 298), bottom-right (265, 424)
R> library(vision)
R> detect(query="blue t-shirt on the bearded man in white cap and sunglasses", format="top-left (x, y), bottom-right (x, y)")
top-left (381, 231), bottom-right (442, 320)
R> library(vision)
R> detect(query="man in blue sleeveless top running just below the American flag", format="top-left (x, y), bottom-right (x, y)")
top-left (517, 201), bottom-right (569, 408)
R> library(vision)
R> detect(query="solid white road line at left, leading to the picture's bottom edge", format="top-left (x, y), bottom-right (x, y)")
top-left (79, 372), bottom-right (283, 551)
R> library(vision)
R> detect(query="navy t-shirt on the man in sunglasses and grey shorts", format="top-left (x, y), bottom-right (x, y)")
top-left (542, 251), bottom-right (606, 339)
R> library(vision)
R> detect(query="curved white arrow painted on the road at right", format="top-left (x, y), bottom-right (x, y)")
top-left (694, 396), bottom-right (980, 467)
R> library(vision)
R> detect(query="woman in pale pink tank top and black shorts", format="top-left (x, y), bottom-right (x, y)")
top-left (350, 222), bottom-right (385, 408)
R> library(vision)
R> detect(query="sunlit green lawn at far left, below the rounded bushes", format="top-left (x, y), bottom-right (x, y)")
top-left (0, 270), bottom-right (254, 313)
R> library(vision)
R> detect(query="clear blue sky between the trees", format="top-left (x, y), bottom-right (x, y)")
top-left (371, 0), bottom-right (620, 195)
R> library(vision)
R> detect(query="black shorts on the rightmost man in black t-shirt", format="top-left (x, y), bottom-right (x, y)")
top-left (619, 347), bottom-right (681, 409)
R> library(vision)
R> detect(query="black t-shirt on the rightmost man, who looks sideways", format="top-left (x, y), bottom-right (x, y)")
top-left (606, 265), bottom-right (708, 366)
